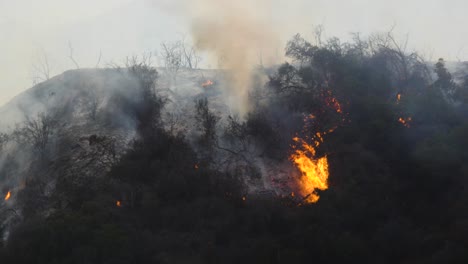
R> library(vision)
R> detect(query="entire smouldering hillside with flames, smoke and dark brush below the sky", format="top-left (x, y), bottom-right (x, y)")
top-left (0, 35), bottom-right (468, 263)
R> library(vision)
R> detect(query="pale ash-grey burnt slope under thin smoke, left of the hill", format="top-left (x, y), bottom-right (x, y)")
top-left (0, 69), bottom-right (148, 191)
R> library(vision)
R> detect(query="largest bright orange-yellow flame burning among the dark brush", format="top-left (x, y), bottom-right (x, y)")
top-left (290, 133), bottom-right (329, 203)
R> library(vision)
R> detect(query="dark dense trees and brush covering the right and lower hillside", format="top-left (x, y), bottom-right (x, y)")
top-left (0, 35), bottom-right (468, 264)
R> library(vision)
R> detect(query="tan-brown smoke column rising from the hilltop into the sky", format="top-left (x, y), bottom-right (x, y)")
top-left (190, 0), bottom-right (279, 116)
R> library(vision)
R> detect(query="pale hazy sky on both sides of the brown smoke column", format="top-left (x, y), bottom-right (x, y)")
top-left (0, 0), bottom-right (468, 104)
